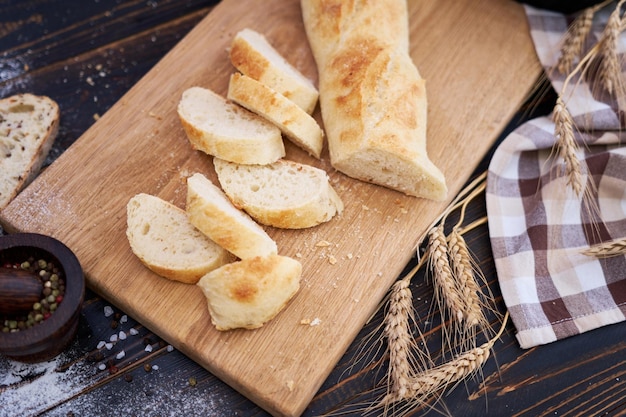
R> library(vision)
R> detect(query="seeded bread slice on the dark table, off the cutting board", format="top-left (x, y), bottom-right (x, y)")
top-left (0, 94), bottom-right (61, 210)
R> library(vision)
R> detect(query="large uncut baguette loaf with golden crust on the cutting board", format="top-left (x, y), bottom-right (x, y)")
top-left (301, 0), bottom-right (447, 201)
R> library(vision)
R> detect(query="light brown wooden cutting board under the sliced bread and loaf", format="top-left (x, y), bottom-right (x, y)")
top-left (0, 0), bottom-right (541, 416)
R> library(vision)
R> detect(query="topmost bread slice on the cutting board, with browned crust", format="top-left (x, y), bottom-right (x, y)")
top-left (230, 29), bottom-right (319, 114)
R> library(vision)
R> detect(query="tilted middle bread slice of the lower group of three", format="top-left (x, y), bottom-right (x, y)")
top-left (186, 173), bottom-right (278, 259)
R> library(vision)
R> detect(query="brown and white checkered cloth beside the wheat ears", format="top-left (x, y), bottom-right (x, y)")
top-left (486, 6), bottom-right (626, 348)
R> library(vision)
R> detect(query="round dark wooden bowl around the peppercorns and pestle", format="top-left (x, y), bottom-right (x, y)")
top-left (0, 233), bottom-right (85, 363)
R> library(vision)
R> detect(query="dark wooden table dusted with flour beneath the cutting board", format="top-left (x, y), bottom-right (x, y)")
top-left (0, 0), bottom-right (626, 416)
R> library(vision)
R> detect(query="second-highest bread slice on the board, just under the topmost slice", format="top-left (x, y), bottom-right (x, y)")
top-left (228, 72), bottom-right (324, 159)
